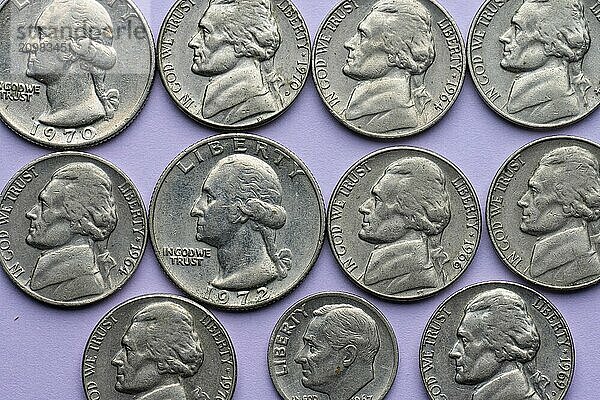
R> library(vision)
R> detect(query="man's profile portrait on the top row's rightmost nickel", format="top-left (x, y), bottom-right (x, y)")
top-left (500, 0), bottom-right (591, 124)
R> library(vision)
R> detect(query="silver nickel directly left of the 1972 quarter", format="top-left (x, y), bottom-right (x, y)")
top-left (0, 152), bottom-right (147, 306)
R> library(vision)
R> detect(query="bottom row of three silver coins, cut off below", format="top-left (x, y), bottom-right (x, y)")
top-left (82, 282), bottom-right (575, 400)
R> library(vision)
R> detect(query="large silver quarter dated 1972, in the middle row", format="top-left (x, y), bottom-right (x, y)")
top-left (150, 134), bottom-right (325, 310)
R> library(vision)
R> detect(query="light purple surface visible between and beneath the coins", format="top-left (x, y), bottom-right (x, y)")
top-left (0, 0), bottom-right (600, 400)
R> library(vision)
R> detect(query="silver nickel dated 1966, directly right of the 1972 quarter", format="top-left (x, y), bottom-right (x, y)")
top-left (327, 147), bottom-right (481, 301)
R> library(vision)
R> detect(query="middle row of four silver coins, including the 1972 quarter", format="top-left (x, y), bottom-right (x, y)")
top-left (0, 134), bottom-right (600, 310)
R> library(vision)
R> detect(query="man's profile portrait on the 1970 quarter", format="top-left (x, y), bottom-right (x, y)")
top-left (26, 0), bottom-right (119, 127)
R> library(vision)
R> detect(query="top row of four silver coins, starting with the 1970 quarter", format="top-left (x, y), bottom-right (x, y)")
top-left (0, 0), bottom-right (600, 148)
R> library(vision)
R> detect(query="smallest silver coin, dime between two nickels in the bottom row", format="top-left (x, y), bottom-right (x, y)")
top-left (267, 292), bottom-right (398, 400)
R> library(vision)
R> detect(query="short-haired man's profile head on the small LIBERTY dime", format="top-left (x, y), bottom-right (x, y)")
top-left (294, 304), bottom-right (380, 400)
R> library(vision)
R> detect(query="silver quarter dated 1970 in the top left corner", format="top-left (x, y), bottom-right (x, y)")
top-left (0, 0), bottom-right (155, 149)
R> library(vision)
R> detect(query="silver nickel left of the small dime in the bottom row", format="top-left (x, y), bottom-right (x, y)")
top-left (81, 294), bottom-right (237, 400)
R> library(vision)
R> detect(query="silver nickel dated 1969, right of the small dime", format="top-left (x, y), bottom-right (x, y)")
top-left (419, 282), bottom-right (575, 400)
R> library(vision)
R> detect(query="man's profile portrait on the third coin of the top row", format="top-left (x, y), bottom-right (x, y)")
top-left (342, 0), bottom-right (435, 133)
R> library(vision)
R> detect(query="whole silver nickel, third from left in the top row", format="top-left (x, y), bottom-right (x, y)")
top-left (312, 0), bottom-right (466, 138)
